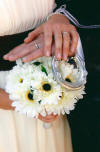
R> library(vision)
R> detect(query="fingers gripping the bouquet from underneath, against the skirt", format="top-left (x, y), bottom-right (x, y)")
top-left (38, 114), bottom-right (59, 123)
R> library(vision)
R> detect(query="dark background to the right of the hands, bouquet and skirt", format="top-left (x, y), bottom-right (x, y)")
top-left (57, 0), bottom-right (100, 152)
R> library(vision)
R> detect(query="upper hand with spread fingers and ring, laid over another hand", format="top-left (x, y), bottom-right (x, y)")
top-left (24, 14), bottom-right (78, 60)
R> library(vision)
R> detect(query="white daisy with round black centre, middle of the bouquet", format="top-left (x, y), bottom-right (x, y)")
top-left (31, 72), bottom-right (62, 104)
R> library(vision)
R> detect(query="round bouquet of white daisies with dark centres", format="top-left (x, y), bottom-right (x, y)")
top-left (6, 57), bottom-right (85, 118)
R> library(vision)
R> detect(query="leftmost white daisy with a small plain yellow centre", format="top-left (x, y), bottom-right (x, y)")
top-left (6, 63), bottom-right (33, 93)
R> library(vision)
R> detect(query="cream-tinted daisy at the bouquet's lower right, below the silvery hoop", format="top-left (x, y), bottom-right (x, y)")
top-left (45, 85), bottom-right (85, 115)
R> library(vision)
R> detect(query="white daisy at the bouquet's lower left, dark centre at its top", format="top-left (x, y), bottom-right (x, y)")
top-left (10, 90), bottom-right (41, 117)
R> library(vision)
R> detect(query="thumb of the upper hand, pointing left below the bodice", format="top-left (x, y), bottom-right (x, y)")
top-left (24, 26), bottom-right (43, 43)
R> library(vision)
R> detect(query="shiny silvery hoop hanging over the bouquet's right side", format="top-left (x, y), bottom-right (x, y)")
top-left (52, 55), bottom-right (87, 91)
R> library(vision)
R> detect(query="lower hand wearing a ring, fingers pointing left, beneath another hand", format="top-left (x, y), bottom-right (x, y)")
top-left (4, 34), bottom-right (44, 62)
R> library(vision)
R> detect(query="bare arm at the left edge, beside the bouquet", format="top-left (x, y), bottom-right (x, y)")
top-left (0, 89), bottom-right (14, 110)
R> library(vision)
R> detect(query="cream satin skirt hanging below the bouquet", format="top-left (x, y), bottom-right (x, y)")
top-left (0, 110), bottom-right (72, 152)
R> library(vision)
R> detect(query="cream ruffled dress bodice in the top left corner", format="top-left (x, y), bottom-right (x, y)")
top-left (0, 0), bottom-right (54, 36)
